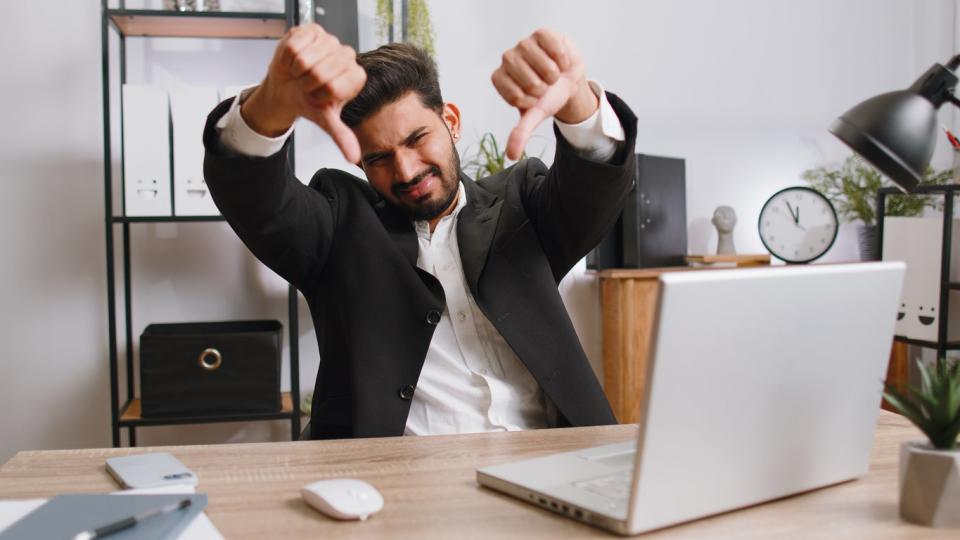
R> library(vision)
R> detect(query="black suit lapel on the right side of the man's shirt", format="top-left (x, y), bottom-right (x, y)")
top-left (457, 173), bottom-right (503, 298)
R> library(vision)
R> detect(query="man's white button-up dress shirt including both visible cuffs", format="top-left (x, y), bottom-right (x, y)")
top-left (217, 81), bottom-right (625, 435)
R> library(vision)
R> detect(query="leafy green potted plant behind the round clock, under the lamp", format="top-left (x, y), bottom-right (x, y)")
top-left (801, 155), bottom-right (953, 261)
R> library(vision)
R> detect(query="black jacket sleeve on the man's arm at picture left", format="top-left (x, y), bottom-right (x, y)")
top-left (203, 96), bottom-right (336, 291)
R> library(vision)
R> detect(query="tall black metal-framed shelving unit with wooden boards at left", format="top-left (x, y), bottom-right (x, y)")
top-left (101, 0), bottom-right (300, 447)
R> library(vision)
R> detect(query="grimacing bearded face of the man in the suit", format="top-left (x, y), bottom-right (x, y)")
top-left (353, 92), bottom-right (460, 221)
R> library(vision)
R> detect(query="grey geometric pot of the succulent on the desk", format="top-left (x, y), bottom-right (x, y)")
top-left (900, 441), bottom-right (960, 528)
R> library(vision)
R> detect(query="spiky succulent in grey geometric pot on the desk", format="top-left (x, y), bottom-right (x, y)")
top-left (884, 357), bottom-right (960, 528)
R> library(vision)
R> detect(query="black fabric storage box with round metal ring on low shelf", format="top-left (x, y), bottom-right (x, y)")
top-left (140, 321), bottom-right (283, 418)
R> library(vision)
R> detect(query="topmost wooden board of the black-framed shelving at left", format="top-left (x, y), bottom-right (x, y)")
top-left (107, 9), bottom-right (287, 39)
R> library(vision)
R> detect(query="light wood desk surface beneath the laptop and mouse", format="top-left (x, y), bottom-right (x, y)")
top-left (0, 412), bottom-right (957, 540)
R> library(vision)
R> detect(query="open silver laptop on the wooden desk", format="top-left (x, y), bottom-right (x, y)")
top-left (477, 262), bottom-right (905, 535)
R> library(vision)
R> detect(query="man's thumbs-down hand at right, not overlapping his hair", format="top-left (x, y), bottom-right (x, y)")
top-left (491, 29), bottom-right (600, 160)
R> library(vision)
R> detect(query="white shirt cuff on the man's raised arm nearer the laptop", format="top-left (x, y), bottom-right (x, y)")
top-left (554, 81), bottom-right (626, 161)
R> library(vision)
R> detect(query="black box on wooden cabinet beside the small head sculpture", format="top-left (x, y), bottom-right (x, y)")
top-left (587, 154), bottom-right (687, 270)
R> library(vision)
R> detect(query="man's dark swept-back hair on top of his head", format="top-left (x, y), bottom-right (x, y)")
top-left (340, 43), bottom-right (443, 127)
